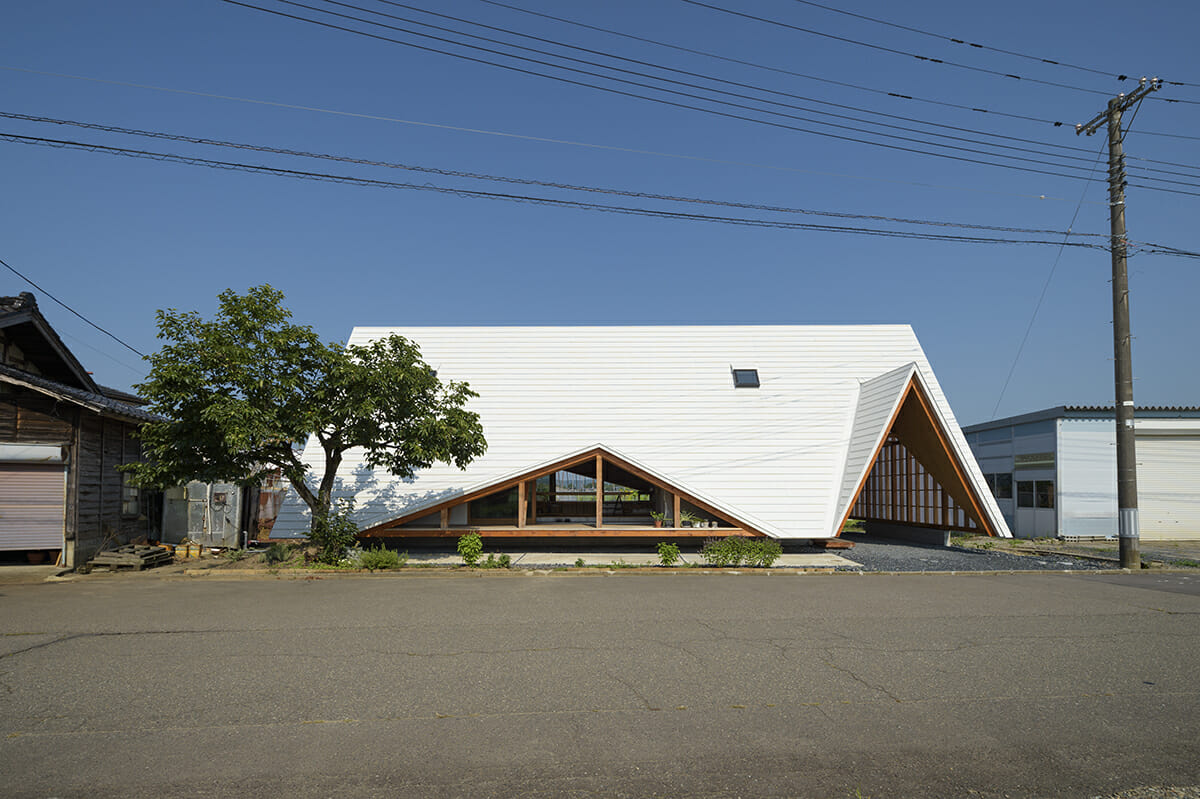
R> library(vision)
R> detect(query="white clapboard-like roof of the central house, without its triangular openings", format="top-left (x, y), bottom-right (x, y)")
top-left (276, 325), bottom-right (1007, 537)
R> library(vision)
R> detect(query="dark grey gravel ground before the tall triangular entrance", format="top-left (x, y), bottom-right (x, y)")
top-left (835, 535), bottom-right (1114, 571)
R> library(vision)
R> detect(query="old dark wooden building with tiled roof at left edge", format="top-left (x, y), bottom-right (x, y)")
top-left (0, 293), bottom-right (157, 566)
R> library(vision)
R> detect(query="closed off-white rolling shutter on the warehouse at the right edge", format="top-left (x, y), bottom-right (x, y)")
top-left (1138, 435), bottom-right (1200, 541)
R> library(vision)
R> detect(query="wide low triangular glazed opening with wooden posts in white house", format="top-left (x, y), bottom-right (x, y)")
top-left (359, 447), bottom-right (763, 537)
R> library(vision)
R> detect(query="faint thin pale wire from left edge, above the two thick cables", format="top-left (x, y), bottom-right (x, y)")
top-left (0, 65), bottom-right (1099, 202)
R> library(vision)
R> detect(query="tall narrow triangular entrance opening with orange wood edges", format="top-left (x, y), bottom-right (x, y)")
top-left (838, 373), bottom-right (1001, 535)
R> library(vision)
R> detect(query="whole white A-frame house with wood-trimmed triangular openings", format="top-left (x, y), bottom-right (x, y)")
top-left (274, 325), bottom-right (1009, 539)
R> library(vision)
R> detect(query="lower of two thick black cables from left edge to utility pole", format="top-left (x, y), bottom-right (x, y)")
top-left (0, 133), bottom-right (1108, 251)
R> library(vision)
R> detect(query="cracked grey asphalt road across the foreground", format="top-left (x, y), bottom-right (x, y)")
top-left (0, 571), bottom-right (1200, 798)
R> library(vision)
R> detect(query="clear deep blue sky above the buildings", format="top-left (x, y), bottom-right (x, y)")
top-left (0, 0), bottom-right (1200, 423)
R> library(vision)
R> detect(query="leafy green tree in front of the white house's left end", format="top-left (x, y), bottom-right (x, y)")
top-left (127, 286), bottom-right (487, 530)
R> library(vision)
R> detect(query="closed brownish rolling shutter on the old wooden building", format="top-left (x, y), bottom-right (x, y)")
top-left (0, 463), bottom-right (66, 549)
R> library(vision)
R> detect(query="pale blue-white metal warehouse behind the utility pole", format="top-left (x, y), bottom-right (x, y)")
top-left (962, 405), bottom-right (1200, 541)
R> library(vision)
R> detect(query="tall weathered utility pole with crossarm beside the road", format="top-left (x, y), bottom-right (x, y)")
top-left (1075, 78), bottom-right (1163, 569)
